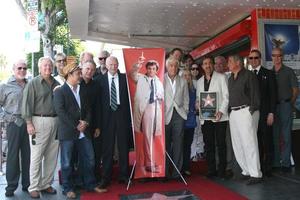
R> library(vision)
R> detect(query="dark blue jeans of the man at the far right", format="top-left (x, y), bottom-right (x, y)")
top-left (273, 102), bottom-right (293, 167)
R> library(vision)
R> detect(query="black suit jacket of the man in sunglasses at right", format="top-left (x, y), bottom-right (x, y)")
top-left (257, 67), bottom-right (277, 122)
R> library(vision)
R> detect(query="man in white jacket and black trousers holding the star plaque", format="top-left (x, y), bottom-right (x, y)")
top-left (197, 57), bottom-right (229, 178)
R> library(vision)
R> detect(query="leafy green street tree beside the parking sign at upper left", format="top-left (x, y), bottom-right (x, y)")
top-left (15, 0), bottom-right (83, 74)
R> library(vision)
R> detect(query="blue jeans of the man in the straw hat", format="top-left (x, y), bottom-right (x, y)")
top-left (60, 137), bottom-right (96, 193)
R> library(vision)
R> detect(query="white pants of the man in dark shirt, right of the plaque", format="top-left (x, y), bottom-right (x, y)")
top-left (229, 107), bottom-right (262, 178)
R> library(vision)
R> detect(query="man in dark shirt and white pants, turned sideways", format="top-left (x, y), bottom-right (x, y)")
top-left (228, 55), bottom-right (262, 185)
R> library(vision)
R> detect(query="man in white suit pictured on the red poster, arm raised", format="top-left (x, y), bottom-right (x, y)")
top-left (130, 57), bottom-right (164, 173)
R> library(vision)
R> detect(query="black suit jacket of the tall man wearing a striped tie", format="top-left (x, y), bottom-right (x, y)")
top-left (95, 72), bottom-right (131, 131)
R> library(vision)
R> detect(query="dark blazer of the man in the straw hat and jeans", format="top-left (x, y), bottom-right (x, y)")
top-left (53, 83), bottom-right (91, 140)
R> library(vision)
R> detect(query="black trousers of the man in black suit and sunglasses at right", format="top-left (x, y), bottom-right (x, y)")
top-left (257, 116), bottom-right (273, 173)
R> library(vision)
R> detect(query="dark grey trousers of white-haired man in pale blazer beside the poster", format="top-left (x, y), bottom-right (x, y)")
top-left (165, 109), bottom-right (184, 178)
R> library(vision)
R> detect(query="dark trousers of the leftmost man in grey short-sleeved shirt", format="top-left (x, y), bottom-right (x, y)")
top-left (6, 122), bottom-right (30, 191)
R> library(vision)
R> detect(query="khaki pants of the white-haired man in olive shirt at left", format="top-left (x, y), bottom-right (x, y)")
top-left (28, 117), bottom-right (59, 192)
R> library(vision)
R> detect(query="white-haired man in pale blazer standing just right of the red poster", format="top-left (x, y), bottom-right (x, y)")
top-left (164, 57), bottom-right (189, 179)
